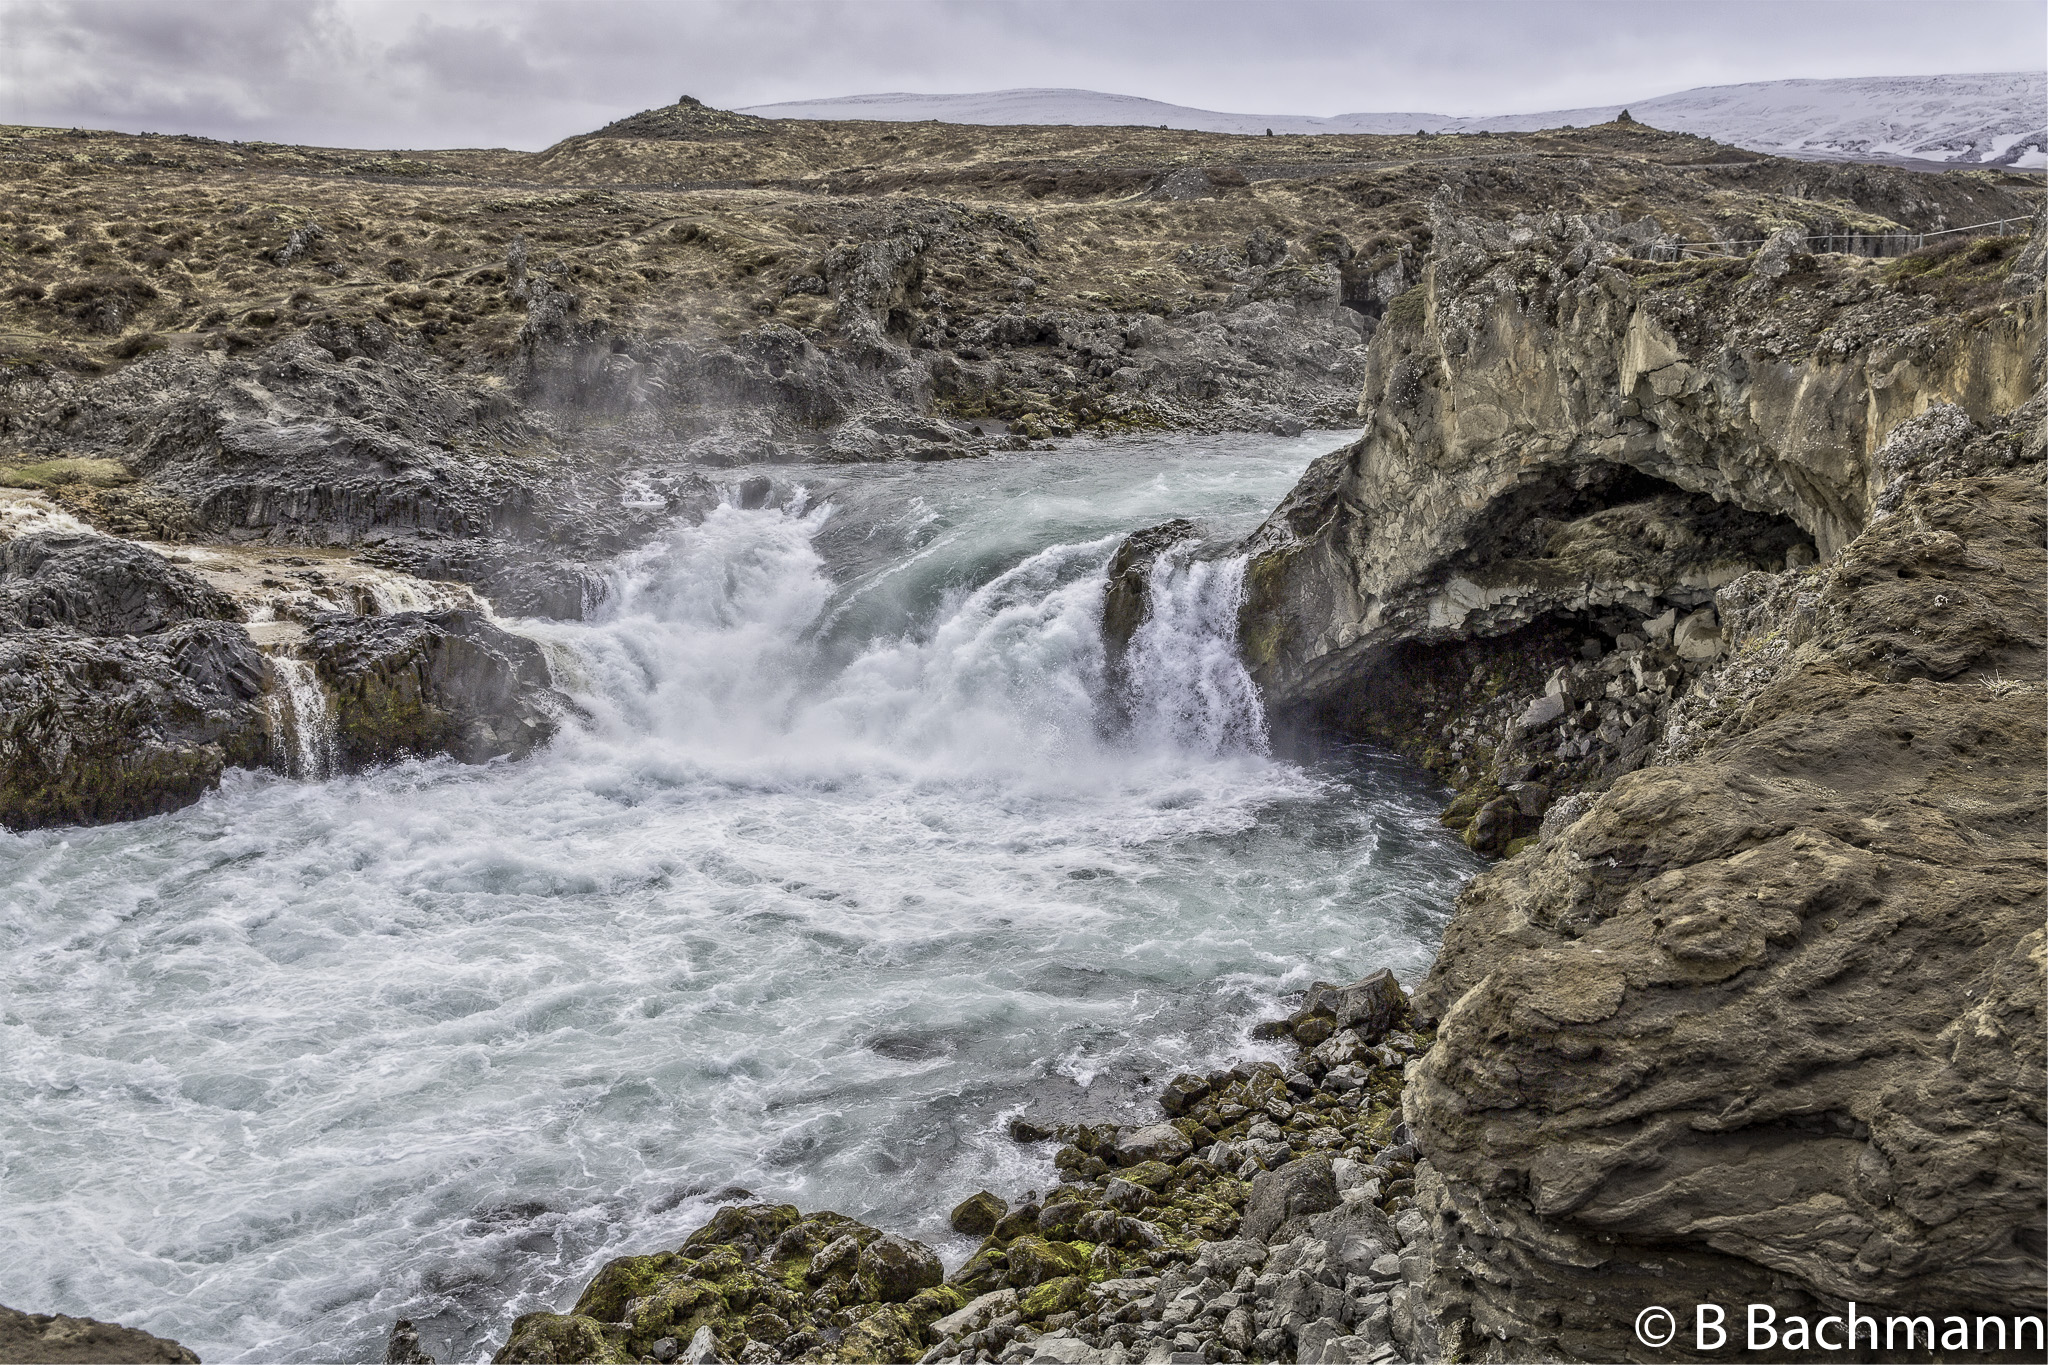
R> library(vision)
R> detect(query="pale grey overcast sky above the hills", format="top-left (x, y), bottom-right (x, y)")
top-left (0, 0), bottom-right (2048, 147)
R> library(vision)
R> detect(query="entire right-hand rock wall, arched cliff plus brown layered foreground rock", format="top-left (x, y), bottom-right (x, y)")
top-left (1220, 205), bottom-right (2048, 1361)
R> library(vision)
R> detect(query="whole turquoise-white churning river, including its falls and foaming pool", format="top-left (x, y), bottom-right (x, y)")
top-left (0, 434), bottom-right (1470, 1361)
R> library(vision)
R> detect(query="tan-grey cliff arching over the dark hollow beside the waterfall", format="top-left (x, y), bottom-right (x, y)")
top-left (1245, 199), bottom-right (2044, 708)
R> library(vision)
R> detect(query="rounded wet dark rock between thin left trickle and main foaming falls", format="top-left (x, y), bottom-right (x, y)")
top-left (307, 610), bottom-right (563, 767)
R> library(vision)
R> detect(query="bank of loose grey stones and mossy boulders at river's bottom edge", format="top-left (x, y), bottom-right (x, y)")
top-left (479, 972), bottom-right (1438, 1365)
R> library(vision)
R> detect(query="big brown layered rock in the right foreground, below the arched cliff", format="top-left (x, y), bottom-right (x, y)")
top-left (1407, 403), bottom-right (2048, 1359)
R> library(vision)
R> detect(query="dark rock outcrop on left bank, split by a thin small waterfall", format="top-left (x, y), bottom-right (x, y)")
top-left (0, 515), bottom-right (561, 829)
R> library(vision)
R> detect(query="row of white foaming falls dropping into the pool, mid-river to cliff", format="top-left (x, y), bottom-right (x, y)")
top-left (551, 505), bottom-right (1266, 780)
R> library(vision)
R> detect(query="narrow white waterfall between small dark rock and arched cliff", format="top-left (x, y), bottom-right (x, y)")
top-left (1124, 544), bottom-right (1268, 755)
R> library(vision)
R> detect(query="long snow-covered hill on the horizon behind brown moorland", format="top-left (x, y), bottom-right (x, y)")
top-left (741, 72), bottom-right (2048, 168)
